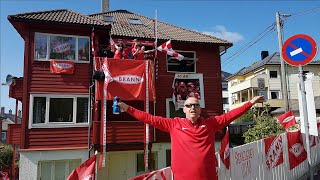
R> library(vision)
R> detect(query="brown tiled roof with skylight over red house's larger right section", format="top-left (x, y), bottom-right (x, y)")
top-left (90, 10), bottom-right (232, 48)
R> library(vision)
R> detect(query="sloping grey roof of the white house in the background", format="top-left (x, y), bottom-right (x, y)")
top-left (227, 52), bottom-right (320, 80)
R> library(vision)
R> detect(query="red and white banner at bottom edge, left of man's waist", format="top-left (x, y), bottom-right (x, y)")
top-left (129, 167), bottom-right (173, 180)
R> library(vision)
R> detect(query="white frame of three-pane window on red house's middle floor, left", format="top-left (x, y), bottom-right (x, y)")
top-left (29, 94), bottom-right (90, 129)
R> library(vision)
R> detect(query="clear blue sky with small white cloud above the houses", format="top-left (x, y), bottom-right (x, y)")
top-left (0, 0), bottom-right (320, 111)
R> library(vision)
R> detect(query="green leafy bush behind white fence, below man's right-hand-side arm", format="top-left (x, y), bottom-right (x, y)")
top-left (243, 114), bottom-right (284, 143)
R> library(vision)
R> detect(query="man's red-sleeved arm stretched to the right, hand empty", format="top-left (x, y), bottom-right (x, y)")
top-left (215, 96), bottom-right (264, 129)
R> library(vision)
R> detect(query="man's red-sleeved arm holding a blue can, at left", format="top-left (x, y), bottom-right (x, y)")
top-left (118, 102), bottom-right (174, 132)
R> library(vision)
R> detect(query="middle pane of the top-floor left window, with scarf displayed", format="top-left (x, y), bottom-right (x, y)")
top-left (50, 36), bottom-right (76, 60)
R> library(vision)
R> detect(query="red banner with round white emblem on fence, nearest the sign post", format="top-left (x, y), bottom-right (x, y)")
top-left (287, 131), bottom-right (307, 170)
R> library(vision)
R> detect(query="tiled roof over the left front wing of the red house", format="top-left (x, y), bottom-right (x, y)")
top-left (8, 9), bottom-right (110, 28)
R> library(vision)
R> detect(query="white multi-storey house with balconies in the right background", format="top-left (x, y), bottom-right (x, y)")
top-left (226, 51), bottom-right (320, 111)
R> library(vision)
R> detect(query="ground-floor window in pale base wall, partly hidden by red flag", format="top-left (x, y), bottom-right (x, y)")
top-left (38, 159), bottom-right (81, 180)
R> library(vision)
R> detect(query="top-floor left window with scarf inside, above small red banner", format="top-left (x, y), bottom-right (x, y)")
top-left (34, 33), bottom-right (90, 62)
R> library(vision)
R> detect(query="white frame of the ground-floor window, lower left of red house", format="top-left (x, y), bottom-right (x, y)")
top-left (37, 159), bottom-right (81, 180)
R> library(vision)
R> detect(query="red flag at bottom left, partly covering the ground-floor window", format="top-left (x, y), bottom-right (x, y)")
top-left (67, 155), bottom-right (97, 180)
